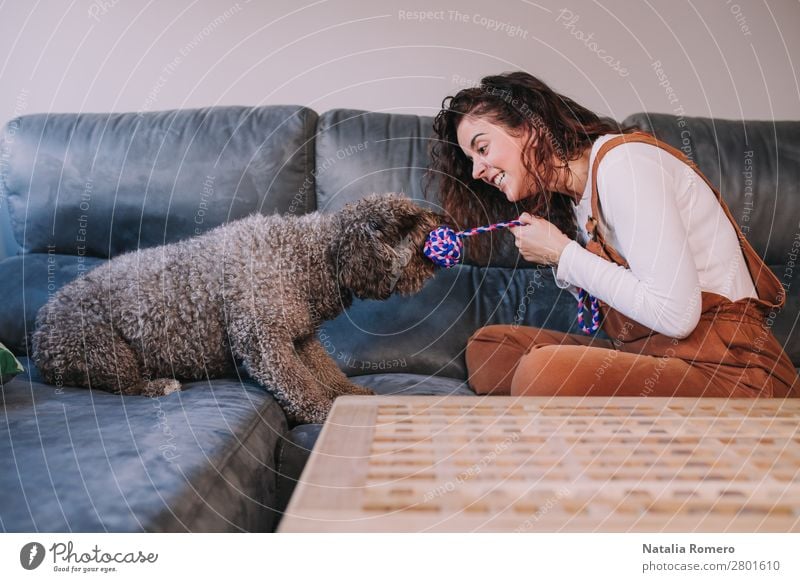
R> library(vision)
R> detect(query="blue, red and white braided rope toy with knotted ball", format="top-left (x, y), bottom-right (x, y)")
top-left (422, 220), bottom-right (600, 335)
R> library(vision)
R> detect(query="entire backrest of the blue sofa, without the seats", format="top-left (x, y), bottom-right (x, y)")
top-left (0, 106), bottom-right (800, 378)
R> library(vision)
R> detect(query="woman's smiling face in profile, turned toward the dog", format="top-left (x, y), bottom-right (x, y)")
top-left (456, 116), bottom-right (531, 202)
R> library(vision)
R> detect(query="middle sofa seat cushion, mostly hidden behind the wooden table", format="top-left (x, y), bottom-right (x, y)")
top-left (276, 373), bottom-right (475, 514)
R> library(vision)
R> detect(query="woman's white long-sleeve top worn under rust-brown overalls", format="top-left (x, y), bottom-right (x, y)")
top-left (555, 135), bottom-right (757, 338)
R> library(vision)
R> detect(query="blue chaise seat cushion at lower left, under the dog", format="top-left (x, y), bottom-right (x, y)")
top-left (0, 361), bottom-right (287, 532)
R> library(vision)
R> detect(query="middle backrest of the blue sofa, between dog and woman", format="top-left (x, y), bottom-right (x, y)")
top-left (315, 109), bottom-right (592, 379)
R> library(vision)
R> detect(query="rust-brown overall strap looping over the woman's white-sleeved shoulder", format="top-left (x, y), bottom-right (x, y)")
top-left (586, 132), bottom-right (786, 309)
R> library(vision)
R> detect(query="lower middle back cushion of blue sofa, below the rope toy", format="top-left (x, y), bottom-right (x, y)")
top-left (320, 266), bottom-right (592, 380)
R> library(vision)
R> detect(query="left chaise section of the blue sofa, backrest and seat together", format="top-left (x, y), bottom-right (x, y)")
top-left (0, 106), bottom-right (317, 531)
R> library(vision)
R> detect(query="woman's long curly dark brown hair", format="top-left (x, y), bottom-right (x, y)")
top-left (425, 71), bottom-right (635, 261)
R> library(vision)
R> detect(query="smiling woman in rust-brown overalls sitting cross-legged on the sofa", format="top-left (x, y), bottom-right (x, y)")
top-left (431, 72), bottom-right (798, 397)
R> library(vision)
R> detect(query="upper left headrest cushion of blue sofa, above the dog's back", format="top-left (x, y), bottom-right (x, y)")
top-left (0, 106), bottom-right (317, 257)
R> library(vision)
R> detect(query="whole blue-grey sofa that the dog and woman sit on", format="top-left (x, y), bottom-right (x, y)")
top-left (0, 106), bottom-right (800, 532)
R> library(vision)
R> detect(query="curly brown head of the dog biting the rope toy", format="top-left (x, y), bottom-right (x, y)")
top-left (333, 194), bottom-right (441, 299)
